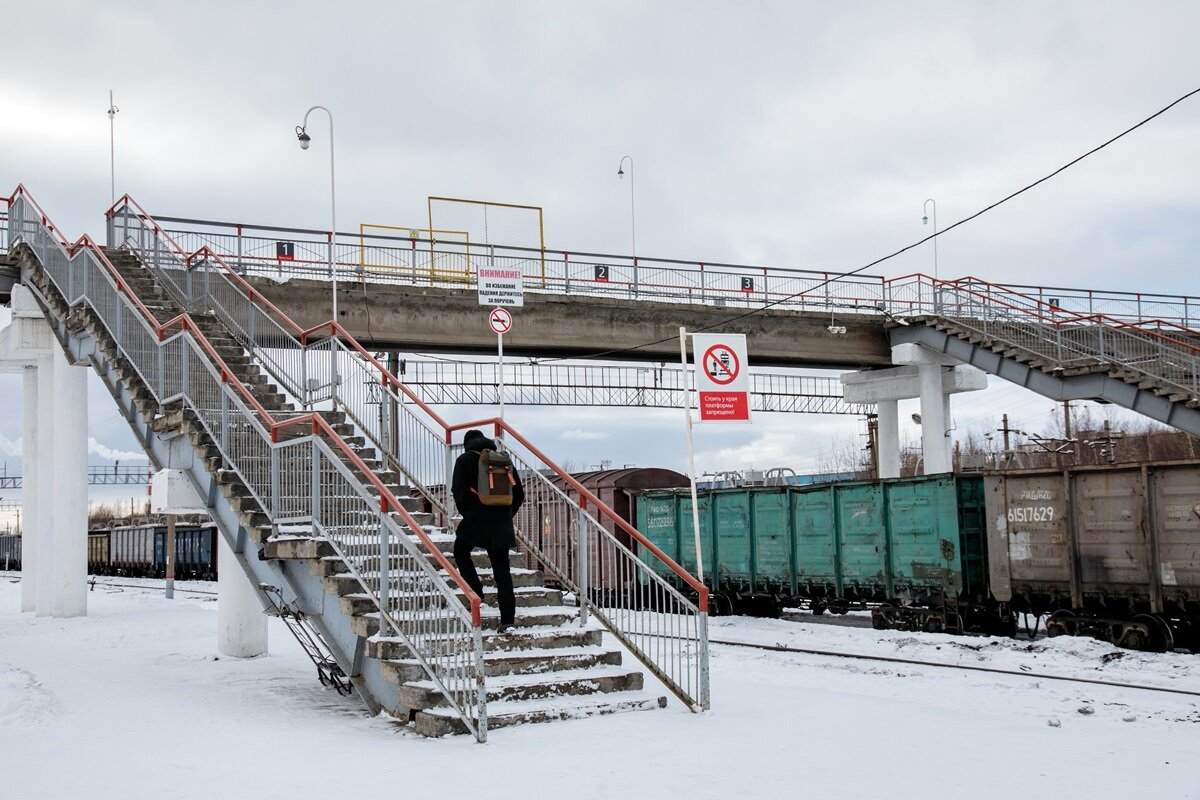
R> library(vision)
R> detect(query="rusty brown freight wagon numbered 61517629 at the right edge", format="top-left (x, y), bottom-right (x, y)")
top-left (985, 462), bottom-right (1200, 651)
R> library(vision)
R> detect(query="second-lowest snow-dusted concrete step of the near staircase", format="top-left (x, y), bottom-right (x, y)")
top-left (396, 666), bottom-right (643, 710)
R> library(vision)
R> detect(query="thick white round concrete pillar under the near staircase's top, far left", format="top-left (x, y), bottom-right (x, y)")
top-left (37, 348), bottom-right (88, 618)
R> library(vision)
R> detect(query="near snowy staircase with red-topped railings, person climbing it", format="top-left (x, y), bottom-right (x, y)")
top-left (8, 187), bottom-right (708, 741)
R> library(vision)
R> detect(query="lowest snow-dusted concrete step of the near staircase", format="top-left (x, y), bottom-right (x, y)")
top-left (414, 691), bottom-right (667, 736)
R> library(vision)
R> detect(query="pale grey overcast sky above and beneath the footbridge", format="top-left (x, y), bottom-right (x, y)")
top-left (0, 0), bottom-right (1200, 525)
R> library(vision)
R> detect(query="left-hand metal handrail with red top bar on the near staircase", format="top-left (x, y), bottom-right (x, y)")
top-left (10, 187), bottom-right (487, 740)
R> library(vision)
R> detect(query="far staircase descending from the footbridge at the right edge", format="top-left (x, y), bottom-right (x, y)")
top-left (888, 278), bottom-right (1200, 435)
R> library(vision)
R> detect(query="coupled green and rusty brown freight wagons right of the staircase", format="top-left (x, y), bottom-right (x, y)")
top-left (631, 462), bottom-right (1200, 651)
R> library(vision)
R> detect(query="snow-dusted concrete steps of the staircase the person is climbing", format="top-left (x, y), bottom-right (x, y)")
top-left (23, 242), bottom-right (666, 735)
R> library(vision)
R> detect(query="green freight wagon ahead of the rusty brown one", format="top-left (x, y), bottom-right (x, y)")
top-left (636, 475), bottom-right (991, 630)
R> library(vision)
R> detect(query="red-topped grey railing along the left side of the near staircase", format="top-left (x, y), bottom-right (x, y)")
top-left (8, 187), bottom-right (487, 740)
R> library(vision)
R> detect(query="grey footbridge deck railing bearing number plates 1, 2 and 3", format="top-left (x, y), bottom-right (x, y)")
top-left (150, 217), bottom-right (1200, 331)
